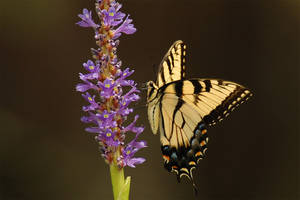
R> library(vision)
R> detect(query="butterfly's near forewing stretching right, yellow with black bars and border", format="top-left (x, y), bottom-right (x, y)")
top-left (159, 79), bottom-right (252, 125)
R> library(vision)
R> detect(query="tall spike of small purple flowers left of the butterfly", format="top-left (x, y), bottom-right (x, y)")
top-left (76, 0), bottom-right (146, 198)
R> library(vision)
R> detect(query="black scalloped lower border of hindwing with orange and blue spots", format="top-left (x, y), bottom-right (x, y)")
top-left (161, 123), bottom-right (208, 180)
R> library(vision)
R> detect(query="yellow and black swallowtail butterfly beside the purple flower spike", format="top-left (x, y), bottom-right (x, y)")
top-left (147, 40), bottom-right (252, 191)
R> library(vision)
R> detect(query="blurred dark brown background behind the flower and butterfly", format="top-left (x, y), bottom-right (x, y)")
top-left (0, 0), bottom-right (300, 200)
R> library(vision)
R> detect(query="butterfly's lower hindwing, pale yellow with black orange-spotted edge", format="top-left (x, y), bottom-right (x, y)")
top-left (160, 94), bottom-right (208, 179)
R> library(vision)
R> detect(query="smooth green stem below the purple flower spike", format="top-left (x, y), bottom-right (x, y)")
top-left (110, 163), bottom-right (130, 200)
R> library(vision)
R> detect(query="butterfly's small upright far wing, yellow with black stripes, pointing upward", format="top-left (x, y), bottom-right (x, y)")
top-left (156, 40), bottom-right (186, 87)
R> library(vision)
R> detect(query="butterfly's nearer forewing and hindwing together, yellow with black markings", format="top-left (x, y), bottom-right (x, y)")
top-left (158, 79), bottom-right (251, 179)
